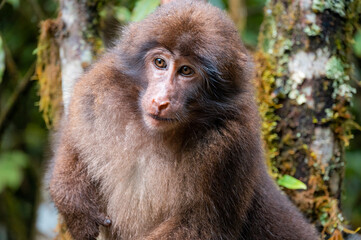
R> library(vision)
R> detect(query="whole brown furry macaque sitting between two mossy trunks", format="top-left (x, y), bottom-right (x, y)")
top-left (50, 0), bottom-right (318, 240)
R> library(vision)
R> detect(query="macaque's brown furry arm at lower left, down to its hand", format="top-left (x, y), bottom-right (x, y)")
top-left (50, 137), bottom-right (111, 240)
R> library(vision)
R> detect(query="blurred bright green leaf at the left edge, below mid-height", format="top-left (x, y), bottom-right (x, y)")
top-left (0, 151), bottom-right (28, 193)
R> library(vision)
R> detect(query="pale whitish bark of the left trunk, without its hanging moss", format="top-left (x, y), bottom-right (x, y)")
top-left (59, 0), bottom-right (100, 114)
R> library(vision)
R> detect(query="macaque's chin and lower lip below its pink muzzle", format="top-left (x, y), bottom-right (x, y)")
top-left (143, 113), bottom-right (177, 132)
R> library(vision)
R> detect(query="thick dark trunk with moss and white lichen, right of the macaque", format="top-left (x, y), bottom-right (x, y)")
top-left (255, 0), bottom-right (361, 239)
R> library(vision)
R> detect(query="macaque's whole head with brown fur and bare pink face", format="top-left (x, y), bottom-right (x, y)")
top-left (116, 0), bottom-right (250, 131)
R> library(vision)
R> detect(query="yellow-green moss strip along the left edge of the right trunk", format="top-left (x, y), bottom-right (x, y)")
top-left (255, 1), bottom-right (296, 175)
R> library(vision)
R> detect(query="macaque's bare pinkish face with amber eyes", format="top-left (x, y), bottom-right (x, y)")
top-left (141, 48), bottom-right (202, 131)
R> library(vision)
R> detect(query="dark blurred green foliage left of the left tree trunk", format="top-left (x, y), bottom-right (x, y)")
top-left (0, 0), bottom-right (57, 237)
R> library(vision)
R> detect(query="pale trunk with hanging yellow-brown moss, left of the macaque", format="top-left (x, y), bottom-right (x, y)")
top-left (36, 0), bottom-right (104, 240)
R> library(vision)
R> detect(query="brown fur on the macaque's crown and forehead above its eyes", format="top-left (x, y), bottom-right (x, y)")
top-left (119, 0), bottom-right (247, 77)
